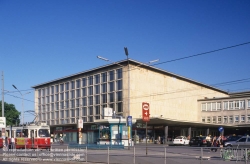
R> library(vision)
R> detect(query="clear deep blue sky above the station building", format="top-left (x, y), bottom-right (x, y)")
top-left (0, 0), bottom-right (250, 122)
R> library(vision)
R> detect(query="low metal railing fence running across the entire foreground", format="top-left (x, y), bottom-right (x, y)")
top-left (2, 144), bottom-right (250, 164)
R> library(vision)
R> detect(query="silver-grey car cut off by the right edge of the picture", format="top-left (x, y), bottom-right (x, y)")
top-left (224, 136), bottom-right (250, 148)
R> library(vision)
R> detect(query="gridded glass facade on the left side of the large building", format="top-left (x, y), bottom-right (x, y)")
top-left (37, 68), bottom-right (123, 125)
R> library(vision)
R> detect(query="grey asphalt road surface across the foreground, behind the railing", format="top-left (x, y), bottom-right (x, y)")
top-left (0, 144), bottom-right (250, 164)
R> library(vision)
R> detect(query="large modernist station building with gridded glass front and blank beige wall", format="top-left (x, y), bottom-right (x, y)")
top-left (33, 59), bottom-right (249, 142)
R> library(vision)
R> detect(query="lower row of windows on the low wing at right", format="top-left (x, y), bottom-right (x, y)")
top-left (201, 115), bottom-right (250, 124)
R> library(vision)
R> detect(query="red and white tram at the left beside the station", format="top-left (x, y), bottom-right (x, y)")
top-left (6, 123), bottom-right (51, 149)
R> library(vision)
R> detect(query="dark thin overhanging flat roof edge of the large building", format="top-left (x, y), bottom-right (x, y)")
top-left (32, 59), bottom-right (228, 94)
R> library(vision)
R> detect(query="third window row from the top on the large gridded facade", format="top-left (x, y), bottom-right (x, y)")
top-left (38, 91), bottom-right (123, 112)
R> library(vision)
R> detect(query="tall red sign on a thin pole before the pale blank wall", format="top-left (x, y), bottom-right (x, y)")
top-left (142, 102), bottom-right (150, 155)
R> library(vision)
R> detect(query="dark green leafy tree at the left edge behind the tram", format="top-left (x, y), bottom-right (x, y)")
top-left (0, 101), bottom-right (21, 125)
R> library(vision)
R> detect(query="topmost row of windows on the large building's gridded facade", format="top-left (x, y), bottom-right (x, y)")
top-left (38, 68), bottom-right (122, 97)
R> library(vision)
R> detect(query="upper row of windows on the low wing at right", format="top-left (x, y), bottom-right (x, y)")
top-left (201, 100), bottom-right (250, 111)
